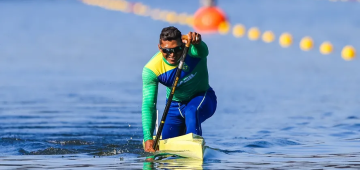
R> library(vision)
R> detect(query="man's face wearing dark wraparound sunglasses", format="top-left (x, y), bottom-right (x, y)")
top-left (158, 40), bottom-right (184, 64)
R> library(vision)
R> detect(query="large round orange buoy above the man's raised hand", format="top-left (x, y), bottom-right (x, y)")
top-left (194, 6), bottom-right (226, 33)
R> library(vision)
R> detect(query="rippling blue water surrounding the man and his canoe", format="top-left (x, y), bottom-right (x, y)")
top-left (0, 0), bottom-right (360, 169)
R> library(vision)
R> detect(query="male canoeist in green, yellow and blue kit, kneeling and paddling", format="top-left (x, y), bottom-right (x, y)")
top-left (142, 26), bottom-right (217, 152)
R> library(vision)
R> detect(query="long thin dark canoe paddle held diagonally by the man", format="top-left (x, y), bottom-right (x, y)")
top-left (153, 35), bottom-right (190, 151)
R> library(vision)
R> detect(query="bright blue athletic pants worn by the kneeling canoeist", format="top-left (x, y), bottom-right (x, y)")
top-left (162, 88), bottom-right (217, 139)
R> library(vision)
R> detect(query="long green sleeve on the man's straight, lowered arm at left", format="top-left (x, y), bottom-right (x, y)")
top-left (141, 67), bottom-right (158, 142)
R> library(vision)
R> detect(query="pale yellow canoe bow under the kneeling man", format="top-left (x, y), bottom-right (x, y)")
top-left (143, 133), bottom-right (205, 160)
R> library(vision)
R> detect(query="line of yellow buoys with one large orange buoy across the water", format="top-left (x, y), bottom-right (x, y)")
top-left (81, 0), bottom-right (360, 61)
